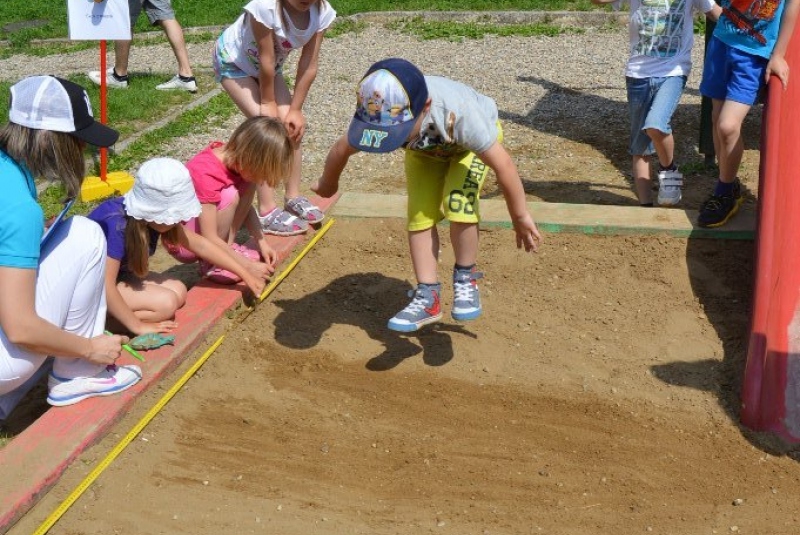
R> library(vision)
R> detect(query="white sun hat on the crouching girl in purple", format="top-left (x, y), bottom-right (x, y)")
top-left (124, 158), bottom-right (202, 225)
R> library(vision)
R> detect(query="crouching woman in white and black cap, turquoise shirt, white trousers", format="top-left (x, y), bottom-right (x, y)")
top-left (0, 76), bottom-right (141, 414)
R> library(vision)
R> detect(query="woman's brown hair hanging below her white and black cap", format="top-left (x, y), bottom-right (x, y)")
top-left (0, 123), bottom-right (86, 198)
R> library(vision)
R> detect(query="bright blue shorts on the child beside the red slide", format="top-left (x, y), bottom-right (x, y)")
top-left (700, 37), bottom-right (769, 106)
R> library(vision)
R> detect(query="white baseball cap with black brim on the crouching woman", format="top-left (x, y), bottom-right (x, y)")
top-left (8, 76), bottom-right (119, 147)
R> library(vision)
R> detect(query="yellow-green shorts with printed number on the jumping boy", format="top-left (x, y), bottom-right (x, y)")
top-left (405, 122), bottom-right (503, 231)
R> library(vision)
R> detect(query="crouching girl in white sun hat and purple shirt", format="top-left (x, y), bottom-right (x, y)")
top-left (89, 158), bottom-right (269, 335)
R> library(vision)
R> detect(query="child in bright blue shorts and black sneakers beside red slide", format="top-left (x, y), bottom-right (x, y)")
top-left (697, 0), bottom-right (800, 227)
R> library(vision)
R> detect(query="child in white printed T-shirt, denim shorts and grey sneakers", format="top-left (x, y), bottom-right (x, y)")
top-left (592, 0), bottom-right (721, 206)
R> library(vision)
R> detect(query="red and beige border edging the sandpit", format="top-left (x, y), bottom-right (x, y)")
top-left (0, 193), bottom-right (755, 533)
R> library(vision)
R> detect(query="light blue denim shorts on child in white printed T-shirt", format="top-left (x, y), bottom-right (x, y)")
top-left (625, 76), bottom-right (686, 156)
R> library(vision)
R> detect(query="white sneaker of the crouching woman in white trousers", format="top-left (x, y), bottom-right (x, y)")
top-left (47, 364), bottom-right (142, 407)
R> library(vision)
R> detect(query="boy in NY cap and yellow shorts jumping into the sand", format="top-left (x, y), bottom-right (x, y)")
top-left (312, 58), bottom-right (541, 332)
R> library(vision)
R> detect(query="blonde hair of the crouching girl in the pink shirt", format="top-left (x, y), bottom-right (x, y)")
top-left (223, 117), bottom-right (294, 188)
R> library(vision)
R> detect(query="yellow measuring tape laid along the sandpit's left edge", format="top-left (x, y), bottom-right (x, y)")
top-left (33, 218), bottom-right (335, 535)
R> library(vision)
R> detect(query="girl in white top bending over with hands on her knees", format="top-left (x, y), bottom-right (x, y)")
top-left (214, 0), bottom-right (336, 236)
